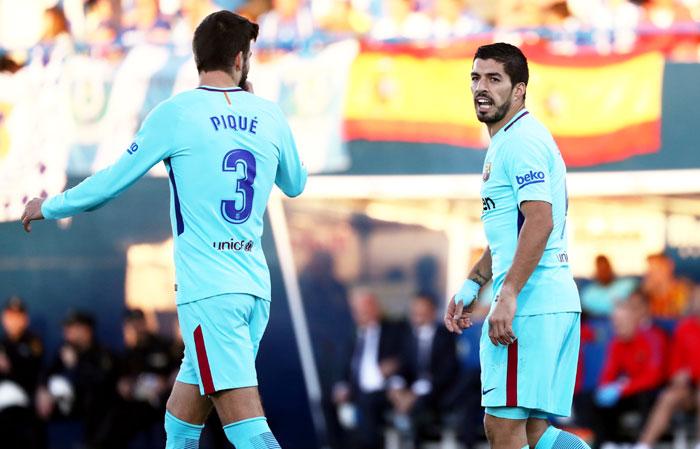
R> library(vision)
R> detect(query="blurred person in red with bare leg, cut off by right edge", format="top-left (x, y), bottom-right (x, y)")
top-left (635, 287), bottom-right (700, 449)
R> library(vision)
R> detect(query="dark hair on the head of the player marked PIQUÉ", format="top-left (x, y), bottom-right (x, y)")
top-left (192, 11), bottom-right (258, 73)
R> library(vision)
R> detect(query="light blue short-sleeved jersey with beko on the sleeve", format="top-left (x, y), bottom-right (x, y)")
top-left (481, 110), bottom-right (581, 315)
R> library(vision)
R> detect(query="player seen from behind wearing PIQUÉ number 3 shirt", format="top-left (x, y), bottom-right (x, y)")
top-left (22, 11), bottom-right (306, 449)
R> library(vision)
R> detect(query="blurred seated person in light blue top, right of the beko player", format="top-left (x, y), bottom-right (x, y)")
top-left (581, 255), bottom-right (637, 317)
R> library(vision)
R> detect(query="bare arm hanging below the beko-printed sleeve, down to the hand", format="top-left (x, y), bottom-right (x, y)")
top-left (489, 201), bottom-right (554, 345)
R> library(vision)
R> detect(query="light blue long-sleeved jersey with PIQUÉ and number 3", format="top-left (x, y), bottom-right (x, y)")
top-left (42, 86), bottom-right (307, 304)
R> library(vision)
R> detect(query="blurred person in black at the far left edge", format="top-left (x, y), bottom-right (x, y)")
top-left (0, 296), bottom-right (44, 398)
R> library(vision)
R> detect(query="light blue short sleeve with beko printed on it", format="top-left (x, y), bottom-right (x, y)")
top-left (503, 136), bottom-right (552, 207)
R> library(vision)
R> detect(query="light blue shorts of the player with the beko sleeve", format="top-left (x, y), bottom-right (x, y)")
top-left (479, 312), bottom-right (581, 419)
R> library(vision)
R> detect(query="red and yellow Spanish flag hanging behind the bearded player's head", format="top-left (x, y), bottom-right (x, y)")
top-left (345, 47), bottom-right (664, 167)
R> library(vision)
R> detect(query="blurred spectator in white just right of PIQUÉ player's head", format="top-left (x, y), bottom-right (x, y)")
top-left (257, 0), bottom-right (315, 51)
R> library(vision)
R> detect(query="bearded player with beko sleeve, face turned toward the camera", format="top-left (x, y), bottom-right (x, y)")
top-left (445, 43), bottom-right (588, 449)
